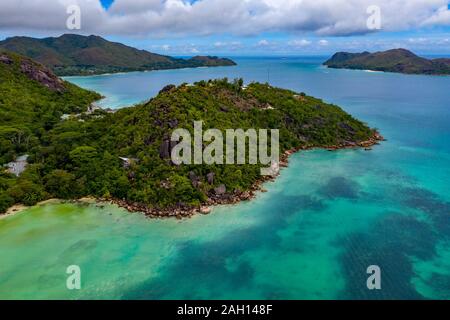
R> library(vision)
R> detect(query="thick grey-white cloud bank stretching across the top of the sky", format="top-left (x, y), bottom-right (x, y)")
top-left (0, 0), bottom-right (450, 38)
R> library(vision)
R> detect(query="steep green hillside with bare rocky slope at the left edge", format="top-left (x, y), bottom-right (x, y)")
top-left (0, 52), bottom-right (101, 163)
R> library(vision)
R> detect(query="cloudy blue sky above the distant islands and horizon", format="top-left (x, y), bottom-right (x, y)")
top-left (0, 0), bottom-right (450, 56)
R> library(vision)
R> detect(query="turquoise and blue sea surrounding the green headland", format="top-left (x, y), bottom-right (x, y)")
top-left (0, 58), bottom-right (450, 299)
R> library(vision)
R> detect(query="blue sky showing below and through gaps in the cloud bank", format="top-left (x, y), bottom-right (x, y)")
top-left (101, 0), bottom-right (450, 55)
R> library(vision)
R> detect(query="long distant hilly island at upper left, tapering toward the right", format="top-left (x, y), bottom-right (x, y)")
top-left (0, 34), bottom-right (236, 76)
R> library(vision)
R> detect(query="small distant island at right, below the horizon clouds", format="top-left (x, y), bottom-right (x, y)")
top-left (324, 49), bottom-right (450, 75)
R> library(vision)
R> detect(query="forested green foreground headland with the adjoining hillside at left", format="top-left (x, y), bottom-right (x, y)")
top-left (0, 52), bottom-right (383, 218)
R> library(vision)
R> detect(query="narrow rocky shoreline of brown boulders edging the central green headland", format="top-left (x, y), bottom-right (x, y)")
top-left (98, 131), bottom-right (385, 219)
